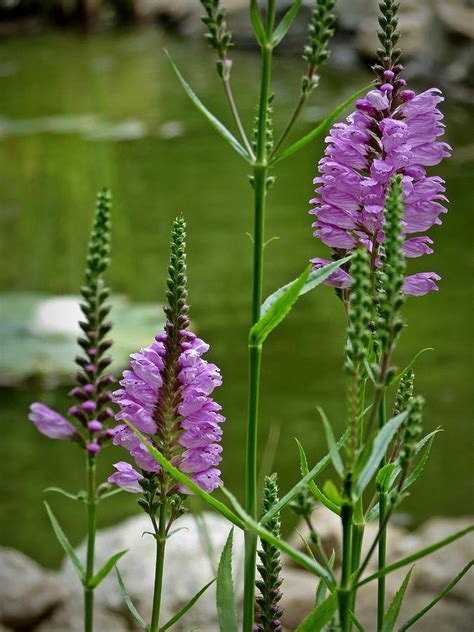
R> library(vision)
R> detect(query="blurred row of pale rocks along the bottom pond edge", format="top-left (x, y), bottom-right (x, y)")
top-left (0, 508), bottom-right (474, 632)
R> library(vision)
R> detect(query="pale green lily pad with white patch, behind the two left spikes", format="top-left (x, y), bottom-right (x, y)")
top-left (0, 292), bottom-right (164, 385)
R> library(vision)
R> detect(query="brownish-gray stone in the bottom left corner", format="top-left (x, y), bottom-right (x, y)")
top-left (0, 548), bottom-right (65, 628)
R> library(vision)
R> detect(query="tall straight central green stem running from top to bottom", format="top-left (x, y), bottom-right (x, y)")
top-left (243, 0), bottom-right (275, 632)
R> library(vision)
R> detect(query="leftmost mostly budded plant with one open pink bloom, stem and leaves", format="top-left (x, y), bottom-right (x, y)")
top-left (29, 189), bottom-right (124, 632)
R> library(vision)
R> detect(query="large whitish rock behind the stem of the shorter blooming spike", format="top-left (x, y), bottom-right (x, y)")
top-left (62, 513), bottom-right (243, 632)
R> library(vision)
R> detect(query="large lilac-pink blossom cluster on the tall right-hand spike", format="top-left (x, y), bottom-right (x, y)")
top-left (310, 80), bottom-right (451, 296)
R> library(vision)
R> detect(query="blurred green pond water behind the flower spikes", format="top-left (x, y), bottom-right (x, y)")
top-left (0, 30), bottom-right (474, 565)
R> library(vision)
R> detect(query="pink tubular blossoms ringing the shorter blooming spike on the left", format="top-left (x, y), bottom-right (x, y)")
top-left (109, 330), bottom-right (224, 492)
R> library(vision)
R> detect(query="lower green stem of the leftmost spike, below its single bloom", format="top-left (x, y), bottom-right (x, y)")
top-left (84, 454), bottom-right (97, 632)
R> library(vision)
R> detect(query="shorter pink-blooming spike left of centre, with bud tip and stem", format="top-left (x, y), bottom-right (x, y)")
top-left (109, 217), bottom-right (224, 632)
